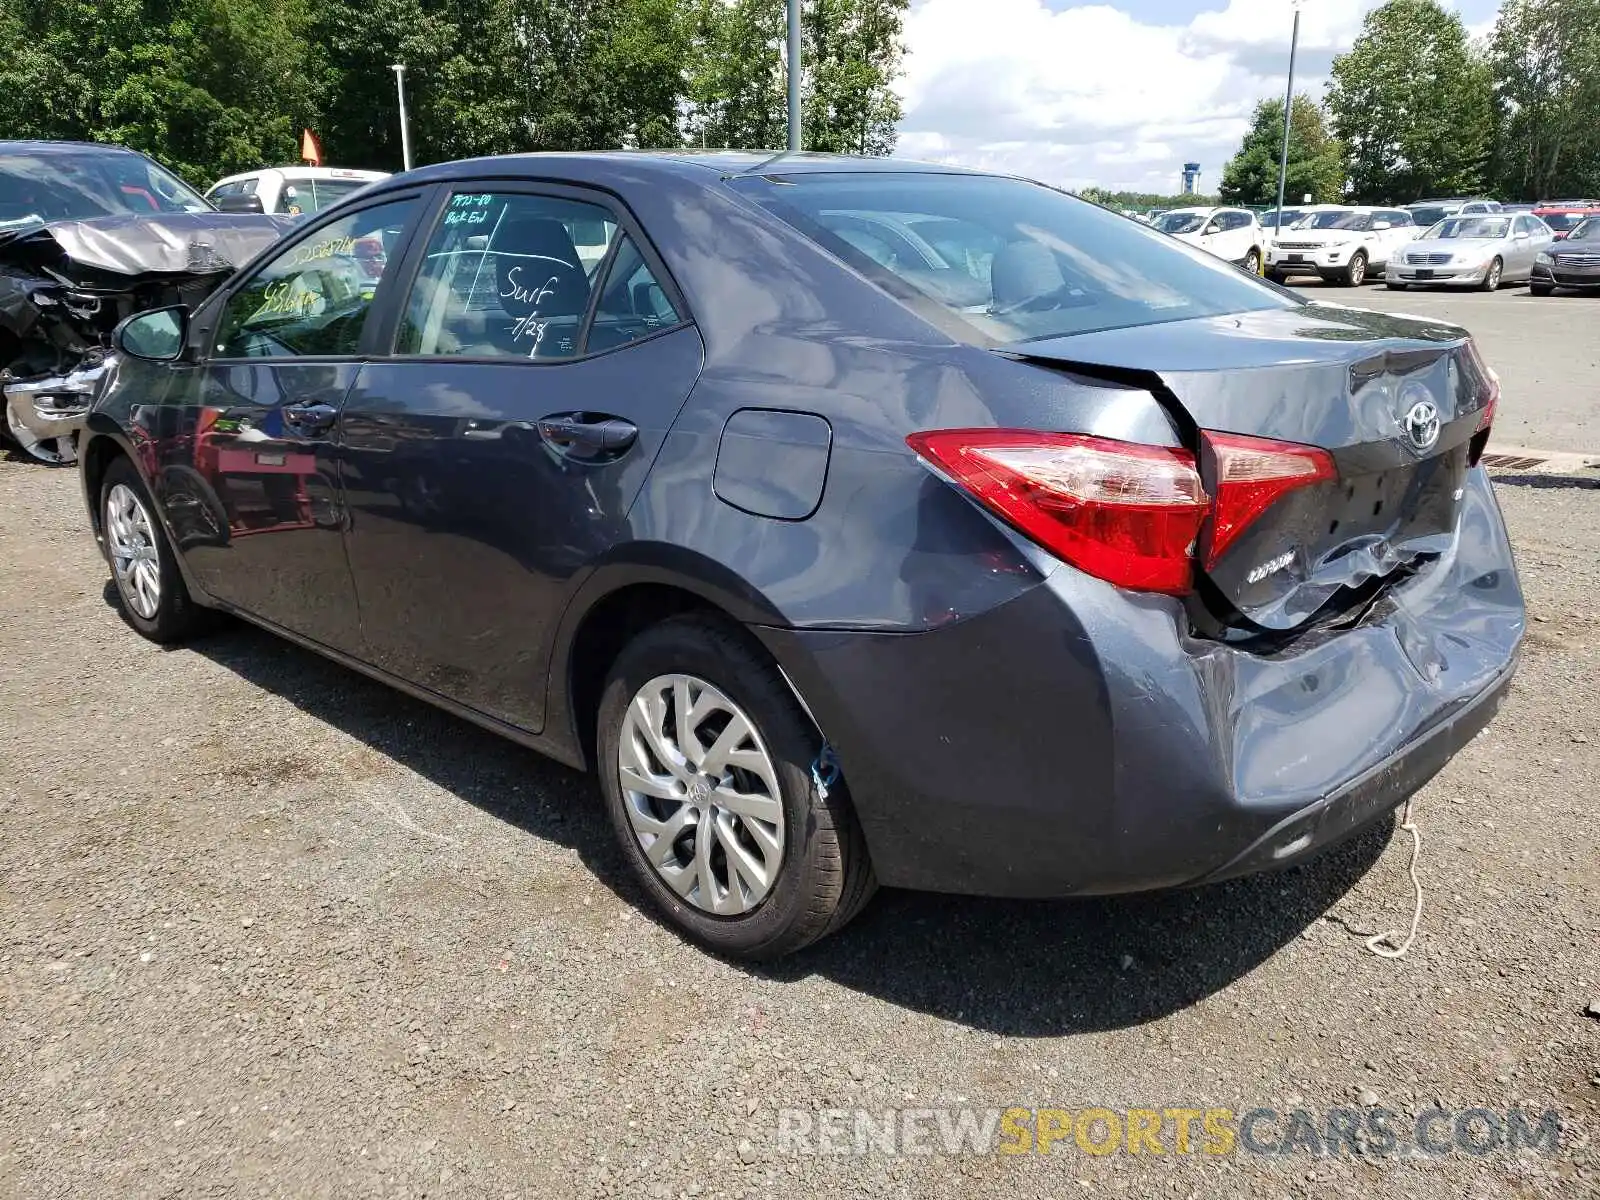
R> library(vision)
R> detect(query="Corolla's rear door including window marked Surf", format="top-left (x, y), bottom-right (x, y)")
top-left (342, 182), bottom-right (701, 731)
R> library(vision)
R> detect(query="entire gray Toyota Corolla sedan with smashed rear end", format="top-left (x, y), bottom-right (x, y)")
top-left (82, 154), bottom-right (1523, 957)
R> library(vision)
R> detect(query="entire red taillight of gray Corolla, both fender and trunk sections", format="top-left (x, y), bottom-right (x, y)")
top-left (906, 429), bottom-right (1336, 595)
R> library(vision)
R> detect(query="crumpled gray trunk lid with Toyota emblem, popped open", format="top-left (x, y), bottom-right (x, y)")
top-left (998, 304), bottom-right (1494, 630)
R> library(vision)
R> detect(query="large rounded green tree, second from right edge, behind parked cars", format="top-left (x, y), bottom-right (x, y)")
top-left (1328, 0), bottom-right (1493, 203)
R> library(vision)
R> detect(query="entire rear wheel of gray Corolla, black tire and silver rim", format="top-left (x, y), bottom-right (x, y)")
top-left (595, 616), bottom-right (877, 960)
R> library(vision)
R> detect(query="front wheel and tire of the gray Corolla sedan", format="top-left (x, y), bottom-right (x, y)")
top-left (99, 458), bottom-right (213, 645)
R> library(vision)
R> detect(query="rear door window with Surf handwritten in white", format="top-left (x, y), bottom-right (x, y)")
top-left (395, 192), bottom-right (616, 358)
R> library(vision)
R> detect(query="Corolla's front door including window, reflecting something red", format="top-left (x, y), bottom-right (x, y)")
top-left (157, 198), bottom-right (418, 653)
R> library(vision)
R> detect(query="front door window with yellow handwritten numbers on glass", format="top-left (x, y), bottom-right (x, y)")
top-left (216, 200), bottom-right (416, 358)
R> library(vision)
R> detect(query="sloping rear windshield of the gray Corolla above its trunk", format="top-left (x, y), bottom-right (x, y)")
top-left (734, 171), bottom-right (1299, 342)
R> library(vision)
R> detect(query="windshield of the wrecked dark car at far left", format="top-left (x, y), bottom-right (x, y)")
top-left (0, 147), bottom-right (211, 230)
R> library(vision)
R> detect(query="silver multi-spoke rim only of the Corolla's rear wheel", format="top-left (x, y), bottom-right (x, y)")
top-left (618, 674), bottom-right (784, 917)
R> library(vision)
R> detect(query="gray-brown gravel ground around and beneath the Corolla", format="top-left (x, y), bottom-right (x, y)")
top-left (0, 312), bottom-right (1600, 1200)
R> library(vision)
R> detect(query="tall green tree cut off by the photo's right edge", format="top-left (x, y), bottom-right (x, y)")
top-left (1490, 0), bottom-right (1600, 200)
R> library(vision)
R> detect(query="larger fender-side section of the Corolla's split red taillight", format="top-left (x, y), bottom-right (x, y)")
top-left (906, 429), bottom-right (1210, 594)
